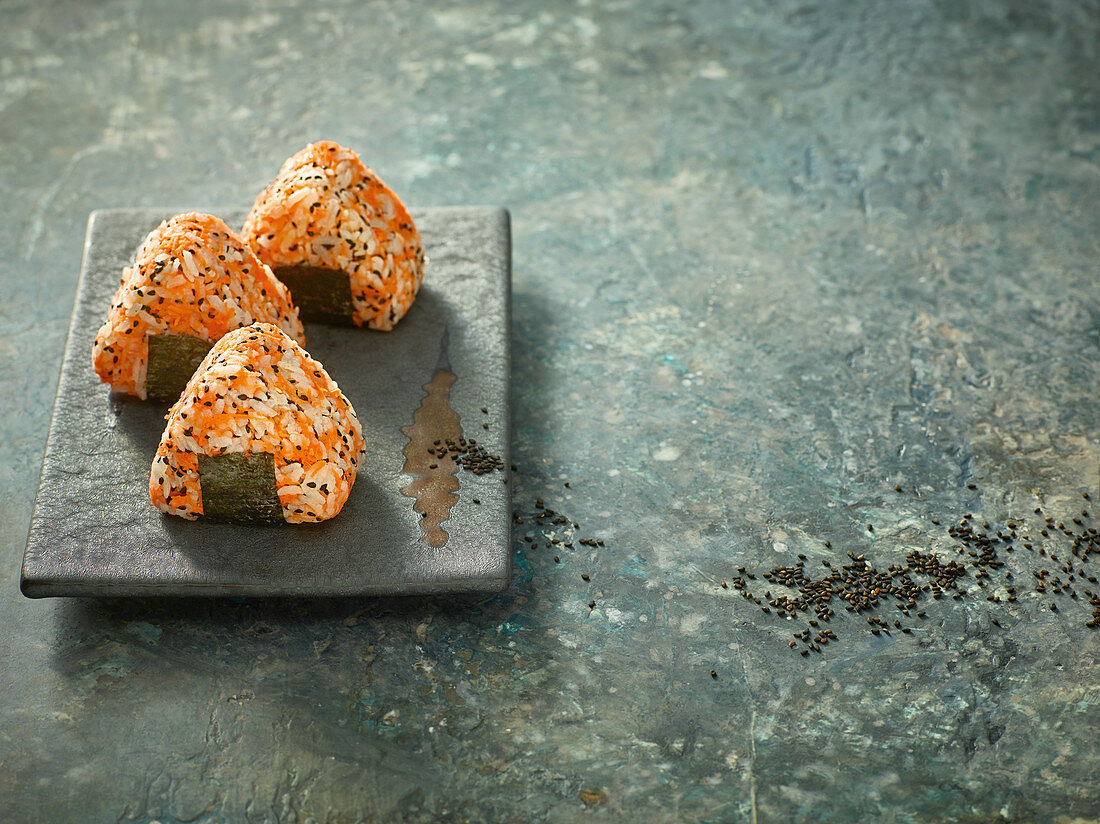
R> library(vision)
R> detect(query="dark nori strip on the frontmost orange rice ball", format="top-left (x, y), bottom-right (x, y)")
top-left (198, 452), bottom-right (284, 524)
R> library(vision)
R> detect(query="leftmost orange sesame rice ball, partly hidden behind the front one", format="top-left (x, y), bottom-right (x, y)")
top-left (92, 212), bottom-right (304, 402)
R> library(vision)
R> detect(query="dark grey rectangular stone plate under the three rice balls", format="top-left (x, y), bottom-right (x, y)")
top-left (21, 207), bottom-right (512, 597)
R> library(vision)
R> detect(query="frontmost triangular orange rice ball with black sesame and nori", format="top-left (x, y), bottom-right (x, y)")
top-left (149, 323), bottom-right (363, 524)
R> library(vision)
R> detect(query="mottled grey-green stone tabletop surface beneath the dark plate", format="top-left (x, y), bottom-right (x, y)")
top-left (0, 0), bottom-right (1100, 824)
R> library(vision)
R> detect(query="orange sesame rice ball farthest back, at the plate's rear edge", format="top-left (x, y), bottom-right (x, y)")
top-left (241, 141), bottom-right (425, 330)
